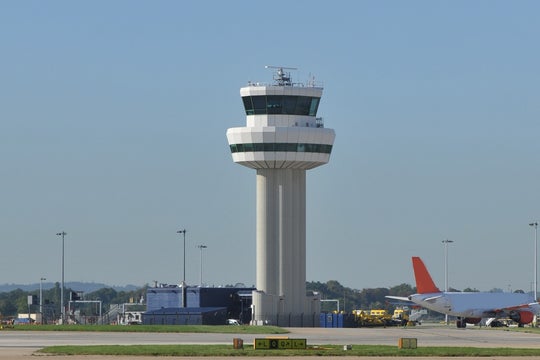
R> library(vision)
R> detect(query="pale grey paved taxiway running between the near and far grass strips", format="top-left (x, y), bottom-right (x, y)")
top-left (0, 325), bottom-right (540, 360)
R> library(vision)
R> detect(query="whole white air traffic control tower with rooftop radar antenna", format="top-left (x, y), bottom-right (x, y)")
top-left (227, 66), bottom-right (335, 326)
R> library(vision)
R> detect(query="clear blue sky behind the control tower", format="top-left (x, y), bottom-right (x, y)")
top-left (0, 0), bottom-right (540, 291)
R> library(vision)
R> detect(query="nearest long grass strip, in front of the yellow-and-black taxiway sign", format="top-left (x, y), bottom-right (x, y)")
top-left (38, 344), bottom-right (540, 357)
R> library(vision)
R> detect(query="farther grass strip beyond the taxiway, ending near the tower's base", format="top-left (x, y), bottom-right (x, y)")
top-left (4, 325), bottom-right (288, 334)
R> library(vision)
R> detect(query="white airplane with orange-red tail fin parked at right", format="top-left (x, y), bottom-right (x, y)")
top-left (387, 256), bottom-right (540, 328)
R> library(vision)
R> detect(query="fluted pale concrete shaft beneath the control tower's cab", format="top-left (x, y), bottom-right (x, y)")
top-left (256, 169), bottom-right (306, 314)
